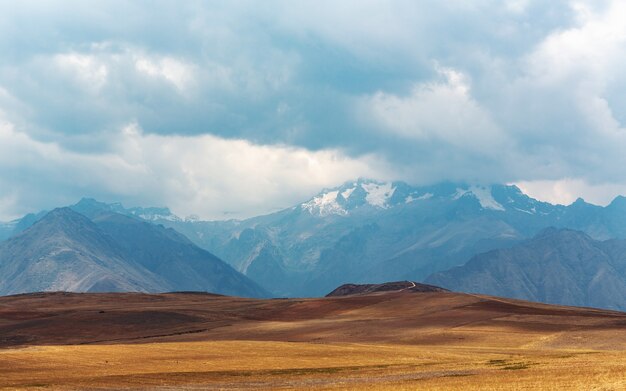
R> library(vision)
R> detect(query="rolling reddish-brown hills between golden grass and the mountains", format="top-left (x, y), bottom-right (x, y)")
top-left (0, 288), bottom-right (626, 349)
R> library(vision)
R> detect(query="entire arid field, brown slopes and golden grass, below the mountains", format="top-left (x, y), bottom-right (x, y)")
top-left (0, 290), bottom-right (626, 390)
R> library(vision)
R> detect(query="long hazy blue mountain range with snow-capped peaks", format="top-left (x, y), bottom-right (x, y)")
top-left (7, 179), bottom-right (626, 296)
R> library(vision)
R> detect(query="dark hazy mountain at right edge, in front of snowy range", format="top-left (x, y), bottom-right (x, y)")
top-left (427, 228), bottom-right (626, 310)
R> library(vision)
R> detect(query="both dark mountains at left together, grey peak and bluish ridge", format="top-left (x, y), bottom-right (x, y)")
top-left (0, 208), bottom-right (266, 296)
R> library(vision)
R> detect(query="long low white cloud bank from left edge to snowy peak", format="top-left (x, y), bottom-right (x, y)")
top-left (0, 123), bottom-right (388, 218)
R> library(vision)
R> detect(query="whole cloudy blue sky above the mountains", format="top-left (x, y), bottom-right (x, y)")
top-left (0, 0), bottom-right (626, 221)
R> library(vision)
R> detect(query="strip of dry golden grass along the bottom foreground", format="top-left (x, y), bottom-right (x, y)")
top-left (0, 341), bottom-right (626, 390)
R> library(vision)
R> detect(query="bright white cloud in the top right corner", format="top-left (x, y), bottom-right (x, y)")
top-left (523, 1), bottom-right (626, 133)
